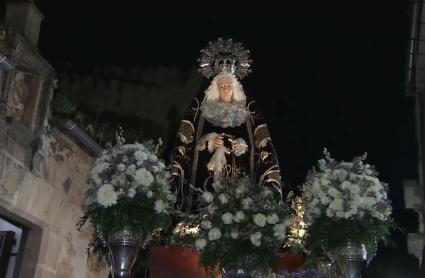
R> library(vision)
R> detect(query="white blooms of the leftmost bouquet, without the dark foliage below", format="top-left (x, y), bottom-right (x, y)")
top-left (86, 142), bottom-right (174, 210)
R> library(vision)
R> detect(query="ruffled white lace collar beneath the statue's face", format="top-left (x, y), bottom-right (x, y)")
top-left (201, 100), bottom-right (247, 127)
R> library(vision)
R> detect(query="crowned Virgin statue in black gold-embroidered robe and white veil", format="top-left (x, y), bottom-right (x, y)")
top-left (171, 39), bottom-right (282, 211)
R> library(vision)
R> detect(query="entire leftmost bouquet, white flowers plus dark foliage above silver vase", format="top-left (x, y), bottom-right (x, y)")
top-left (78, 137), bottom-right (175, 258)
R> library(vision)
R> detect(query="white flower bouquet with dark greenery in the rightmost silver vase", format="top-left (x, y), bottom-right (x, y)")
top-left (302, 149), bottom-right (392, 260)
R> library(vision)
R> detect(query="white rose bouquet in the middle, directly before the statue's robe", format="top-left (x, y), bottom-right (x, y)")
top-left (188, 176), bottom-right (293, 274)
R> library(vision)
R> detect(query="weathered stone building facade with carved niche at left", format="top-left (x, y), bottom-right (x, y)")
top-left (0, 1), bottom-right (107, 278)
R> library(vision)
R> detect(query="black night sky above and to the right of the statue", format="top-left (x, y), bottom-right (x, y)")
top-left (16, 0), bottom-right (416, 277)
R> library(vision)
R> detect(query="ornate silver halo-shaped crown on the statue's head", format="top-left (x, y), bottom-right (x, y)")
top-left (198, 38), bottom-right (252, 79)
